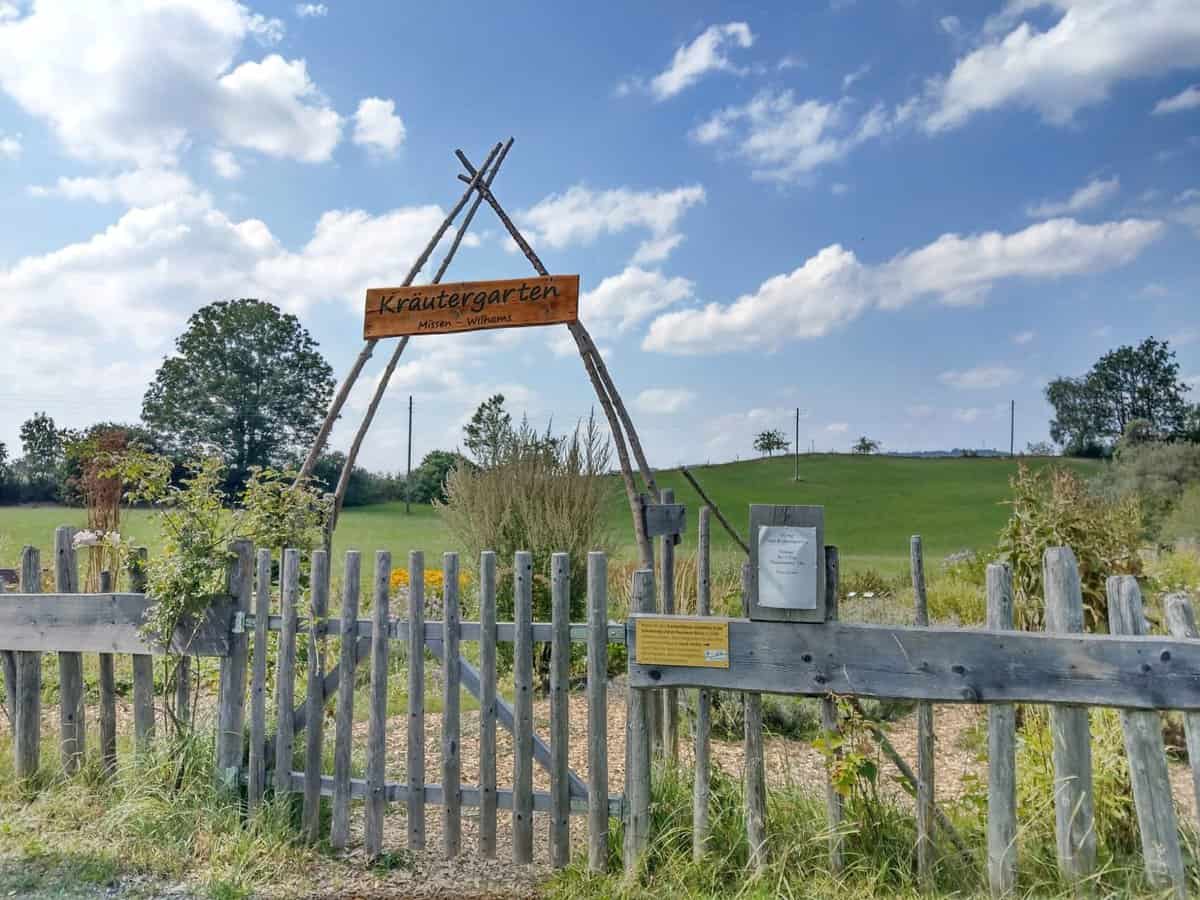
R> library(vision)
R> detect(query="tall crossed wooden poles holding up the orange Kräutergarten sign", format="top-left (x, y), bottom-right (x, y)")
top-left (300, 138), bottom-right (659, 570)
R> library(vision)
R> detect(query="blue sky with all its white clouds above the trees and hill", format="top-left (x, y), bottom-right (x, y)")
top-left (0, 0), bottom-right (1200, 469)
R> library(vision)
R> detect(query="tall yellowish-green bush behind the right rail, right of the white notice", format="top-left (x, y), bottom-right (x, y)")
top-left (1000, 463), bottom-right (1142, 632)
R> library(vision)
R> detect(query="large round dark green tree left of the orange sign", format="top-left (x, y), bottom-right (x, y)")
top-left (142, 299), bottom-right (334, 491)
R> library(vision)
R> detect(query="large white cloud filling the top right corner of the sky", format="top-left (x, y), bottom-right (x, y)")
top-left (925, 0), bottom-right (1200, 132)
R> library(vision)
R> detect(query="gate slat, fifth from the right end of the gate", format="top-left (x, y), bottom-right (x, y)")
top-left (442, 553), bottom-right (462, 859)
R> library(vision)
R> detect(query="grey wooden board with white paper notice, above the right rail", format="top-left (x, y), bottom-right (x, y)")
top-left (750, 504), bottom-right (826, 622)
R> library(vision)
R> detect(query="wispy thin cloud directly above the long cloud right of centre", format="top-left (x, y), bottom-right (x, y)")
top-left (691, 90), bottom-right (896, 181)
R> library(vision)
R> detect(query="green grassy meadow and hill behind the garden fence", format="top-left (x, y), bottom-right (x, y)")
top-left (0, 454), bottom-right (1099, 574)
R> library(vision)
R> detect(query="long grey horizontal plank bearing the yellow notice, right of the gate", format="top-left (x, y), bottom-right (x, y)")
top-left (628, 614), bottom-right (1200, 710)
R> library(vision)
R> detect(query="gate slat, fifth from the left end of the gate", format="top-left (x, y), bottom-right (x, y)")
top-left (362, 550), bottom-right (391, 859)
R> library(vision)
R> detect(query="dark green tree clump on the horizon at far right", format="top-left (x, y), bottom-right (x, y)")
top-left (1045, 337), bottom-right (1192, 456)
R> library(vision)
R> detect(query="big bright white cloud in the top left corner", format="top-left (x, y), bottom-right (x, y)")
top-left (0, 0), bottom-right (341, 168)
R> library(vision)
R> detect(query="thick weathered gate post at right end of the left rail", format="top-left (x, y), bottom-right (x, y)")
top-left (217, 540), bottom-right (254, 791)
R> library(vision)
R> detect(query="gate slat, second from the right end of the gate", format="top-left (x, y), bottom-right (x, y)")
top-left (550, 553), bottom-right (571, 869)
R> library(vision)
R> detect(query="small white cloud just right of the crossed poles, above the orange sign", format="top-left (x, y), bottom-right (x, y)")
top-left (517, 185), bottom-right (704, 264)
